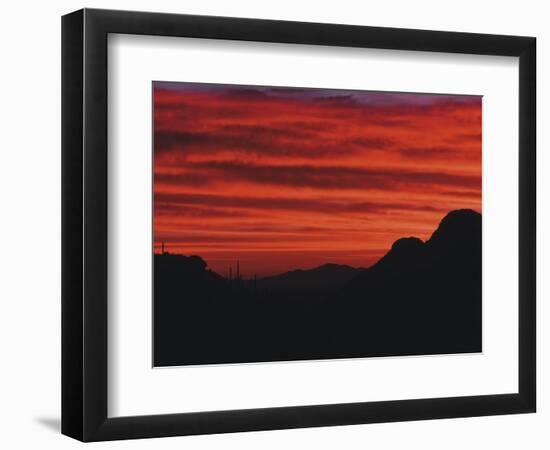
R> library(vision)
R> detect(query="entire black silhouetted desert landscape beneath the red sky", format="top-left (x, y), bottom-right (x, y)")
top-left (154, 210), bottom-right (481, 366)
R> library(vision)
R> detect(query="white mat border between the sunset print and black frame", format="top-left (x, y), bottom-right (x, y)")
top-left (108, 36), bottom-right (518, 416)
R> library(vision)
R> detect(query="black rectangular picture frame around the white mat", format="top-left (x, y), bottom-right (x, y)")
top-left (62, 9), bottom-right (536, 441)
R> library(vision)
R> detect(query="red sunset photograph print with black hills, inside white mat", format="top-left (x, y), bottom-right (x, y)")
top-left (152, 81), bottom-right (482, 367)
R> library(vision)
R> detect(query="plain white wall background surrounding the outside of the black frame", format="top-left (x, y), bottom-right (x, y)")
top-left (0, 0), bottom-right (550, 449)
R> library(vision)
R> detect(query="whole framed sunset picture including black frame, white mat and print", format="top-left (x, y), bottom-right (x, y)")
top-left (62, 9), bottom-right (536, 441)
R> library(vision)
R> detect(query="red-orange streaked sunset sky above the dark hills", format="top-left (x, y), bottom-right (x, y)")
top-left (153, 82), bottom-right (481, 277)
